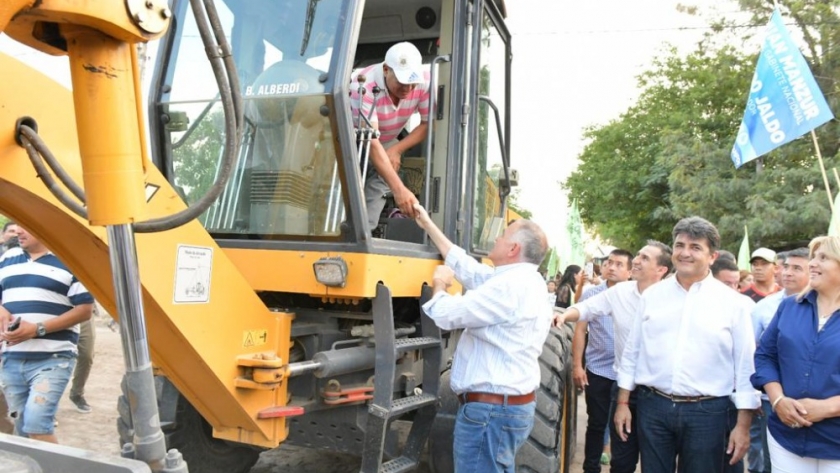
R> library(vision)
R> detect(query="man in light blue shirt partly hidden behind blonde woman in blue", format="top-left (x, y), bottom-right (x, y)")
top-left (749, 248), bottom-right (809, 473)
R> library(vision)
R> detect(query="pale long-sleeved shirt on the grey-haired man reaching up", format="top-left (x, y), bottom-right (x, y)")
top-left (423, 247), bottom-right (553, 395)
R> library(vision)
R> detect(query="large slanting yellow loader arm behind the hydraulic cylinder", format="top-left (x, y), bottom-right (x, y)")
top-left (0, 51), bottom-right (292, 447)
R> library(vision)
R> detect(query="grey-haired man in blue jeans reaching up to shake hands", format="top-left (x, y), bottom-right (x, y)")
top-left (414, 204), bottom-right (552, 473)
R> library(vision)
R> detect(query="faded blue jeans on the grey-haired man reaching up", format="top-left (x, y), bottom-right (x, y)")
top-left (454, 402), bottom-right (537, 473)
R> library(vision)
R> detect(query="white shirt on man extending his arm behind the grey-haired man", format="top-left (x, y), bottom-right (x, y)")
top-left (572, 281), bottom-right (642, 372)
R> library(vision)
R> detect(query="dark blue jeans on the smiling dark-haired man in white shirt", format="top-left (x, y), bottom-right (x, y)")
top-left (636, 386), bottom-right (738, 473)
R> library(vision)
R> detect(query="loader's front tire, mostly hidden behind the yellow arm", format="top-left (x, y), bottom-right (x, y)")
top-left (117, 376), bottom-right (260, 473)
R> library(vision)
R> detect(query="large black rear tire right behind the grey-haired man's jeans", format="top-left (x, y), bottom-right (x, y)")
top-left (516, 324), bottom-right (575, 473)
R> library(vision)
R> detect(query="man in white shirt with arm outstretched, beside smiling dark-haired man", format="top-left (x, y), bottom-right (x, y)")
top-left (554, 240), bottom-right (671, 473)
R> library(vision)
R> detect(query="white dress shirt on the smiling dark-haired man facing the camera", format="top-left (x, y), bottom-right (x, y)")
top-left (618, 273), bottom-right (760, 409)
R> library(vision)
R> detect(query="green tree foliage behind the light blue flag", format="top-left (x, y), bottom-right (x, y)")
top-left (563, 0), bottom-right (840, 249)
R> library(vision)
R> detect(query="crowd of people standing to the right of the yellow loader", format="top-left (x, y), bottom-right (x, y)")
top-left (415, 205), bottom-right (840, 473)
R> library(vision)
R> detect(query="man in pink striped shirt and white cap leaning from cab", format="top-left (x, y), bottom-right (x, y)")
top-left (350, 42), bottom-right (429, 229)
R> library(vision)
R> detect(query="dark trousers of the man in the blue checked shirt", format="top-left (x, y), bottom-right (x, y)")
top-left (583, 370), bottom-right (615, 473)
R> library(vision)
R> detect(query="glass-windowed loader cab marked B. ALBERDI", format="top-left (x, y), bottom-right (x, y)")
top-left (149, 0), bottom-right (511, 254)
